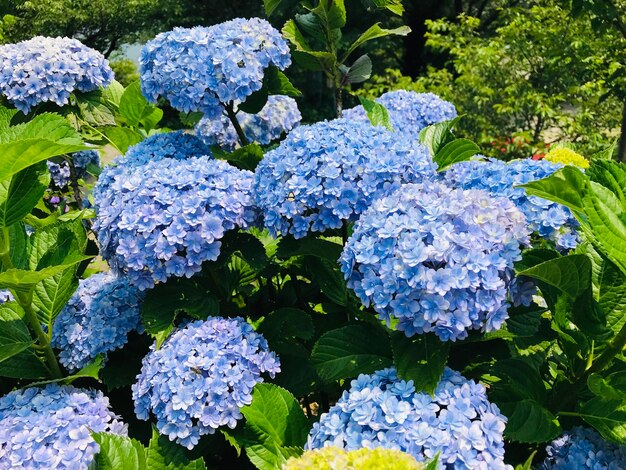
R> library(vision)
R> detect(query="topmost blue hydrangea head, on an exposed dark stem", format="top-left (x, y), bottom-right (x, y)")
top-left (140, 18), bottom-right (291, 119)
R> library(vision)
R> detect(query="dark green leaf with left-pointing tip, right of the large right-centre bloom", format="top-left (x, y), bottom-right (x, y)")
top-left (517, 255), bottom-right (591, 297)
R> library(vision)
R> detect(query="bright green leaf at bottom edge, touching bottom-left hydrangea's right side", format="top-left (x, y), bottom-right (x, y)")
top-left (92, 432), bottom-right (151, 470)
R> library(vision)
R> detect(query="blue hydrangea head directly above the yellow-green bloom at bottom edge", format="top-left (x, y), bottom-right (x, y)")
top-left (306, 368), bottom-right (511, 470)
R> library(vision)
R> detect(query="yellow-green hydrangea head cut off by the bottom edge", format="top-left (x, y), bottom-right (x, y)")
top-left (283, 446), bottom-right (424, 470)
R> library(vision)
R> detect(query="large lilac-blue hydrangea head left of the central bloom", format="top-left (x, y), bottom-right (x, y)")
top-left (93, 152), bottom-right (257, 289)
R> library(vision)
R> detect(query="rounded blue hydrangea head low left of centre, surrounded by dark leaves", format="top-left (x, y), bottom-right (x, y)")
top-left (132, 317), bottom-right (280, 449)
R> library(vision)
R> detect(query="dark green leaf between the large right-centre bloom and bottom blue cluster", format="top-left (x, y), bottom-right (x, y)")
top-left (391, 331), bottom-right (450, 395)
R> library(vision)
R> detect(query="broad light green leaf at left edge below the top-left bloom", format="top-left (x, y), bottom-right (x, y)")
top-left (0, 114), bottom-right (89, 181)
